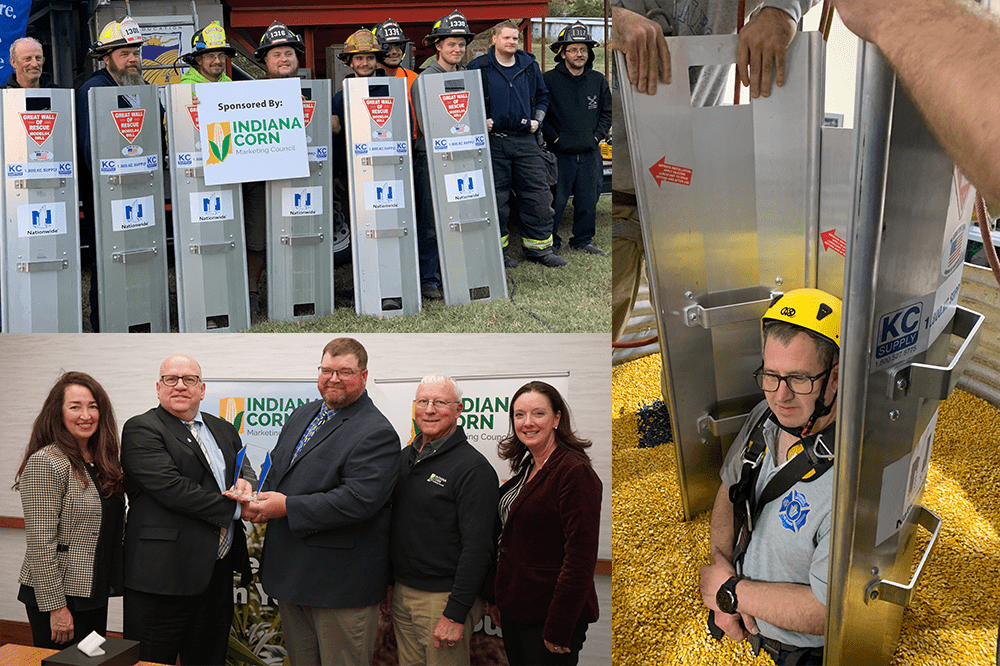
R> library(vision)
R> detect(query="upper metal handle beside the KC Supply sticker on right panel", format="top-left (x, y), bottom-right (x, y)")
top-left (889, 306), bottom-right (986, 400)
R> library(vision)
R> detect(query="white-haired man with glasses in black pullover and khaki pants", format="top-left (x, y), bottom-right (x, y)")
top-left (391, 375), bottom-right (500, 666)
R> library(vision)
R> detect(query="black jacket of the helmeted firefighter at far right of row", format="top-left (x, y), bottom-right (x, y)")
top-left (542, 62), bottom-right (611, 154)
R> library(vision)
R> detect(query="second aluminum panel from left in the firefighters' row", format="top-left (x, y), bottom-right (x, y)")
top-left (88, 85), bottom-right (170, 333)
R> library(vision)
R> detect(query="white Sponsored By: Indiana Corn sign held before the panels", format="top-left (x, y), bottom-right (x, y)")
top-left (195, 79), bottom-right (309, 185)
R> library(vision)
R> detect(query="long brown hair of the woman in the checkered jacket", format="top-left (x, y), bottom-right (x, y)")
top-left (13, 372), bottom-right (124, 497)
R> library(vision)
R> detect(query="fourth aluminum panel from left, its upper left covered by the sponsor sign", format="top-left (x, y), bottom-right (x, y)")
top-left (262, 79), bottom-right (334, 321)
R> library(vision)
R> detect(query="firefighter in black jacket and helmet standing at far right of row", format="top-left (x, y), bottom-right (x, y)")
top-left (542, 21), bottom-right (611, 255)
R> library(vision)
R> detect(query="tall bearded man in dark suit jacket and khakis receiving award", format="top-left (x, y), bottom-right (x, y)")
top-left (233, 338), bottom-right (400, 666)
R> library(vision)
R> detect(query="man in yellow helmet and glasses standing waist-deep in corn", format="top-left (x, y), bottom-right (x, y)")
top-left (700, 289), bottom-right (841, 664)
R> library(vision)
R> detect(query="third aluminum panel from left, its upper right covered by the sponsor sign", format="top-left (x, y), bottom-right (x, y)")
top-left (164, 83), bottom-right (250, 333)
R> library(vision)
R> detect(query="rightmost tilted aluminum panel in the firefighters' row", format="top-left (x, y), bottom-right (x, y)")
top-left (413, 71), bottom-right (507, 305)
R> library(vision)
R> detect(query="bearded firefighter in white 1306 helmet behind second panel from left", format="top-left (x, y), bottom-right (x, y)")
top-left (76, 16), bottom-right (146, 333)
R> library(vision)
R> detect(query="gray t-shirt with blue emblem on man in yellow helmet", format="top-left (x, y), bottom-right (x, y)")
top-left (720, 401), bottom-right (834, 647)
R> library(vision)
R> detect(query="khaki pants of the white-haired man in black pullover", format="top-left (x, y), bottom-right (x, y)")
top-left (392, 583), bottom-right (483, 666)
